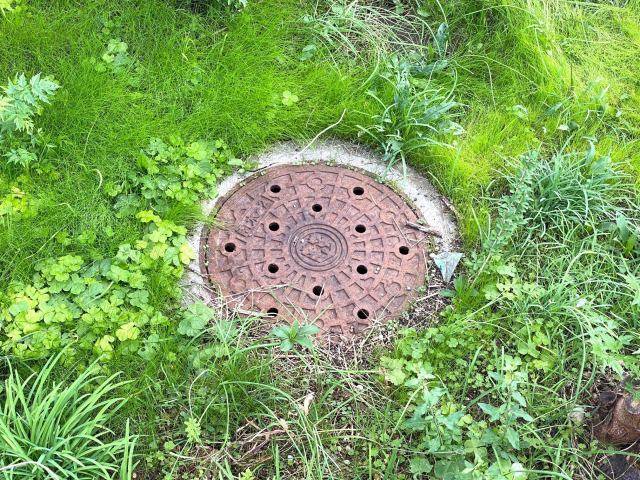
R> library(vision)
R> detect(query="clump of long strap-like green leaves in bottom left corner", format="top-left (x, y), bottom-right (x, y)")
top-left (0, 351), bottom-right (136, 480)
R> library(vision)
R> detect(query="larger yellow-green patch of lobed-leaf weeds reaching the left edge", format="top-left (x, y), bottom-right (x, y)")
top-left (0, 211), bottom-right (193, 358)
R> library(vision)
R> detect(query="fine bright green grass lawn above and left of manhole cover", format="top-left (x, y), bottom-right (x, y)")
top-left (0, 1), bottom-right (370, 285)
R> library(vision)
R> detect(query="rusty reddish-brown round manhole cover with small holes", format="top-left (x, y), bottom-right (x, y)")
top-left (202, 165), bottom-right (426, 335)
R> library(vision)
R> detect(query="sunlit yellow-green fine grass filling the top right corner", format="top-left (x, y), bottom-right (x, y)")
top-left (415, 0), bottom-right (640, 240)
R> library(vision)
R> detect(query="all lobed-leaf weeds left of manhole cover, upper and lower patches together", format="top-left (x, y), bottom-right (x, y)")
top-left (0, 134), bottom-right (242, 359)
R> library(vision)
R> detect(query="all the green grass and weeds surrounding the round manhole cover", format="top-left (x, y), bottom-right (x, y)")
top-left (0, 0), bottom-right (640, 480)
